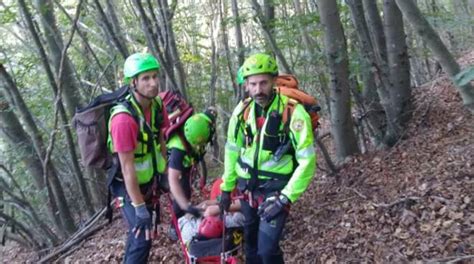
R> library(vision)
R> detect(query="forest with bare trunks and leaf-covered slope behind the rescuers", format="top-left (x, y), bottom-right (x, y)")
top-left (0, 0), bottom-right (474, 263)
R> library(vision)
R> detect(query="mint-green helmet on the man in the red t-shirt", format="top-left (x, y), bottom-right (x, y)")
top-left (123, 53), bottom-right (160, 84)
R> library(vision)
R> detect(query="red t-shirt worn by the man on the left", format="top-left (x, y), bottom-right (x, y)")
top-left (110, 103), bottom-right (169, 153)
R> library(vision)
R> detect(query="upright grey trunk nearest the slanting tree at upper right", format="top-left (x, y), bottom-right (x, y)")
top-left (383, 0), bottom-right (413, 146)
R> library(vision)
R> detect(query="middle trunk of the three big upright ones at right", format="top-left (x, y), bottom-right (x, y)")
top-left (346, 0), bottom-right (386, 144)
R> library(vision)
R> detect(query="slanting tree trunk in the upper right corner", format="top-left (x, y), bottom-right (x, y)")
top-left (396, 0), bottom-right (474, 113)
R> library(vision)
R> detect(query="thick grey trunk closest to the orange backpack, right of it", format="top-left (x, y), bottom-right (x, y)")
top-left (319, 0), bottom-right (359, 161)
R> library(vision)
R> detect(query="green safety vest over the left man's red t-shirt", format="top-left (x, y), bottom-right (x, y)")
top-left (107, 95), bottom-right (166, 185)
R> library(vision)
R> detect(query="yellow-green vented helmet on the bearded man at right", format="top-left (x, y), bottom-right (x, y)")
top-left (242, 53), bottom-right (278, 78)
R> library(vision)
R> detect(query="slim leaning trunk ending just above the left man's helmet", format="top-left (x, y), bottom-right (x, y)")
top-left (94, 0), bottom-right (129, 59)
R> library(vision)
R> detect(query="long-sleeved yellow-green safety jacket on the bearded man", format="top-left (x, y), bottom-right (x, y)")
top-left (221, 94), bottom-right (316, 202)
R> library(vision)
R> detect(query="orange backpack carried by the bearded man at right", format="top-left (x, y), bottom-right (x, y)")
top-left (243, 74), bottom-right (321, 131)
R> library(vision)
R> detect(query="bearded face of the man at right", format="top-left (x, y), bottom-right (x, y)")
top-left (245, 74), bottom-right (274, 107)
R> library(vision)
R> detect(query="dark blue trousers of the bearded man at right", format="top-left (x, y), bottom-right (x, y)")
top-left (240, 200), bottom-right (288, 264)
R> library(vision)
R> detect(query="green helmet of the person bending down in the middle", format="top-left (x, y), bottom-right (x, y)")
top-left (184, 113), bottom-right (213, 146)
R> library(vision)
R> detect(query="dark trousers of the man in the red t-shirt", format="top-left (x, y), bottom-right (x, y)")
top-left (110, 180), bottom-right (152, 264)
